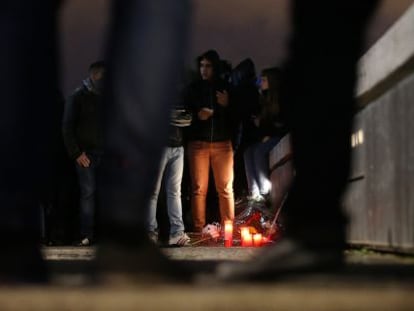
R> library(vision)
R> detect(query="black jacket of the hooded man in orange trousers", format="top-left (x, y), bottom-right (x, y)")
top-left (186, 80), bottom-right (234, 142)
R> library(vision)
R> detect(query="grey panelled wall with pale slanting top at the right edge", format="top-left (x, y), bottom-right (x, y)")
top-left (344, 5), bottom-right (414, 252)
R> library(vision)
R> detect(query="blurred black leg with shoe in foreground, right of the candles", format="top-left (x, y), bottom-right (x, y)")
top-left (218, 0), bottom-right (379, 281)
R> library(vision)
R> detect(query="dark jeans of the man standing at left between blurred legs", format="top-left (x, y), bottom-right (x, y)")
top-left (76, 153), bottom-right (101, 239)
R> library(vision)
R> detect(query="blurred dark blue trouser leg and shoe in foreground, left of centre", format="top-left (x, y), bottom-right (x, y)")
top-left (94, 0), bottom-right (190, 278)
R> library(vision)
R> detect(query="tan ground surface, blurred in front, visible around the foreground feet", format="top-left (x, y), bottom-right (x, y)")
top-left (0, 246), bottom-right (414, 311)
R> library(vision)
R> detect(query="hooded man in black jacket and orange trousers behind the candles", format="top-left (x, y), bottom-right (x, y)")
top-left (186, 50), bottom-right (234, 232)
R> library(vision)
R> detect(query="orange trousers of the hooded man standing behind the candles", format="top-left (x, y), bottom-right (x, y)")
top-left (188, 141), bottom-right (234, 232)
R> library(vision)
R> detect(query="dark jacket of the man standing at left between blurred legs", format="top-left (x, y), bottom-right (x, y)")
top-left (63, 79), bottom-right (103, 159)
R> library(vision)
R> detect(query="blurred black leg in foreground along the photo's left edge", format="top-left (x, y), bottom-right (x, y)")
top-left (0, 0), bottom-right (59, 282)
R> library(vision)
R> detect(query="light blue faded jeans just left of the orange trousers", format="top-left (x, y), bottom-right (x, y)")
top-left (147, 147), bottom-right (184, 237)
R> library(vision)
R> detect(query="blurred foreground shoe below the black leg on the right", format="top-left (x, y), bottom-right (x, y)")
top-left (216, 238), bottom-right (344, 282)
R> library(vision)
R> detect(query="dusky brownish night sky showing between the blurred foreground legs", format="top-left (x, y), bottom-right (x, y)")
top-left (61, 0), bottom-right (414, 95)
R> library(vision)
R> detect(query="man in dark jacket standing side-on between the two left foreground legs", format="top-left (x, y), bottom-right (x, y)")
top-left (62, 61), bottom-right (105, 246)
